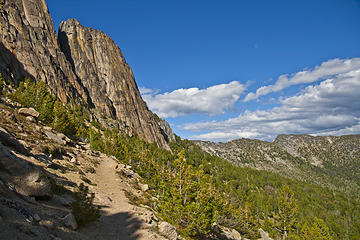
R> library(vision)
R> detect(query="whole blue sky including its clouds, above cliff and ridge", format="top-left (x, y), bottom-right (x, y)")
top-left (47, 0), bottom-right (360, 141)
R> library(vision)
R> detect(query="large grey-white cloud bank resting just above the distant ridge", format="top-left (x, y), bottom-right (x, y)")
top-left (183, 67), bottom-right (360, 141)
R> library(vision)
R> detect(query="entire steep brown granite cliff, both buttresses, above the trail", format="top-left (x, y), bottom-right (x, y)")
top-left (0, 0), bottom-right (172, 149)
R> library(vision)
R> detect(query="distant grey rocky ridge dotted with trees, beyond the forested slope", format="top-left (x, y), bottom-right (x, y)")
top-left (195, 135), bottom-right (360, 192)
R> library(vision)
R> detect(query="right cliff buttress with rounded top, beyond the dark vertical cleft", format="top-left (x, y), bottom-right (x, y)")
top-left (58, 19), bottom-right (168, 148)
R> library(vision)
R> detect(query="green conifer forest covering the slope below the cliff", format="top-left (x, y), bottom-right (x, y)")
top-left (1, 75), bottom-right (360, 239)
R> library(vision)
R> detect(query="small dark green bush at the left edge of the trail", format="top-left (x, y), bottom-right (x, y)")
top-left (72, 183), bottom-right (100, 226)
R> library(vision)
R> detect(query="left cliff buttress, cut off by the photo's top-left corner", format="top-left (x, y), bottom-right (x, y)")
top-left (0, 0), bottom-right (86, 102)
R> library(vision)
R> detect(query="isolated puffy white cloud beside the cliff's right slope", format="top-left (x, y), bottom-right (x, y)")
top-left (142, 81), bottom-right (245, 118)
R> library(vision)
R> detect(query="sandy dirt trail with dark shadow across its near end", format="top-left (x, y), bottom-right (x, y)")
top-left (78, 154), bottom-right (164, 240)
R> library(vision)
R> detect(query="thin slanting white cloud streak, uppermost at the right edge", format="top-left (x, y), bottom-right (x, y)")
top-left (243, 58), bottom-right (360, 102)
